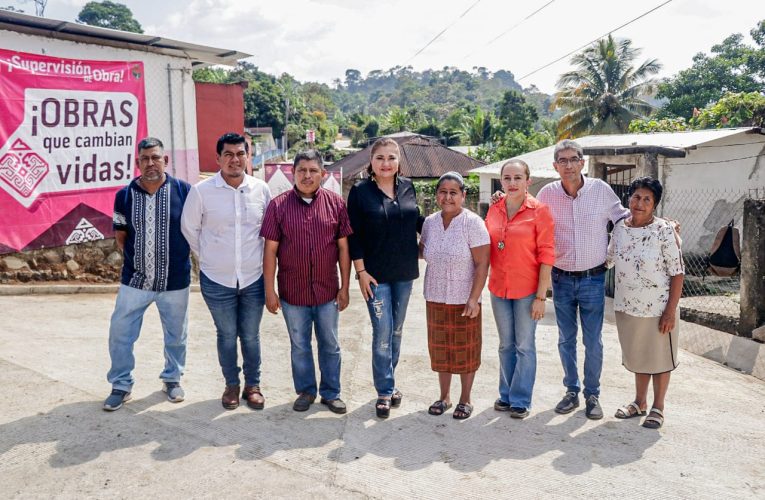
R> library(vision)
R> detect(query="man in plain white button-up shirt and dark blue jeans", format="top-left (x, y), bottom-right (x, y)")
top-left (181, 133), bottom-right (271, 410)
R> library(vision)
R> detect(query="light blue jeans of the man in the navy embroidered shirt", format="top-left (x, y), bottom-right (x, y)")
top-left (106, 285), bottom-right (189, 392)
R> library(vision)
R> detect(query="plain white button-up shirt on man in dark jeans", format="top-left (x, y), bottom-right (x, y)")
top-left (181, 172), bottom-right (271, 288)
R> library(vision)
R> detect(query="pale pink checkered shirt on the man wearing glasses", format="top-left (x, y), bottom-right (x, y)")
top-left (537, 176), bottom-right (629, 271)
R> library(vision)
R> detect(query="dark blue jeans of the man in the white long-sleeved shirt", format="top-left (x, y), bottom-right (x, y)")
top-left (199, 272), bottom-right (266, 386)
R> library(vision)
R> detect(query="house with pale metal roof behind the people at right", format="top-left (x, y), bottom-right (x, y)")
top-left (473, 127), bottom-right (765, 254)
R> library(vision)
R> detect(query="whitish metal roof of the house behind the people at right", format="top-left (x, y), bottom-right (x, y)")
top-left (471, 127), bottom-right (757, 179)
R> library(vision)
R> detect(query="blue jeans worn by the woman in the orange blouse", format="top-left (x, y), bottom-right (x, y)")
top-left (491, 293), bottom-right (537, 409)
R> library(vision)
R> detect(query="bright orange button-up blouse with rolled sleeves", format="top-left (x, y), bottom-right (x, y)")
top-left (486, 194), bottom-right (555, 299)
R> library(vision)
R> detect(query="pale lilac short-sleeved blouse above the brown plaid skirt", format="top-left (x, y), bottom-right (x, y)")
top-left (420, 208), bottom-right (489, 304)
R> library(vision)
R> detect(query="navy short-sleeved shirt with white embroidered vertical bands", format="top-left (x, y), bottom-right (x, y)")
top-left (113, 175), bottom-right (191, 292)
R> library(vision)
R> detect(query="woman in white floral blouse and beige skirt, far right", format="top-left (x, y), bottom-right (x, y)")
top-left (608, 177), bottom-right (684, 429)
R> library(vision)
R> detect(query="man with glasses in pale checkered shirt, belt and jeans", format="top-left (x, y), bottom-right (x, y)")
top-left (537, 139), bottom-right (629, 420)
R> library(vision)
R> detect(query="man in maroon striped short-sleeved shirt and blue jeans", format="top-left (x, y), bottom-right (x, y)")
top-left (260, 150), bottom-right (351, 413)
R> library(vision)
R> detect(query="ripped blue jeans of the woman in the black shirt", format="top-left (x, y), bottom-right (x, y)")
top-left (367, 281), bottom-right (412, 397)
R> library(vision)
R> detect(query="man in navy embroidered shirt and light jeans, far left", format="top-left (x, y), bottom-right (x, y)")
top-left (103, 137), bottom-right (191, 411)
